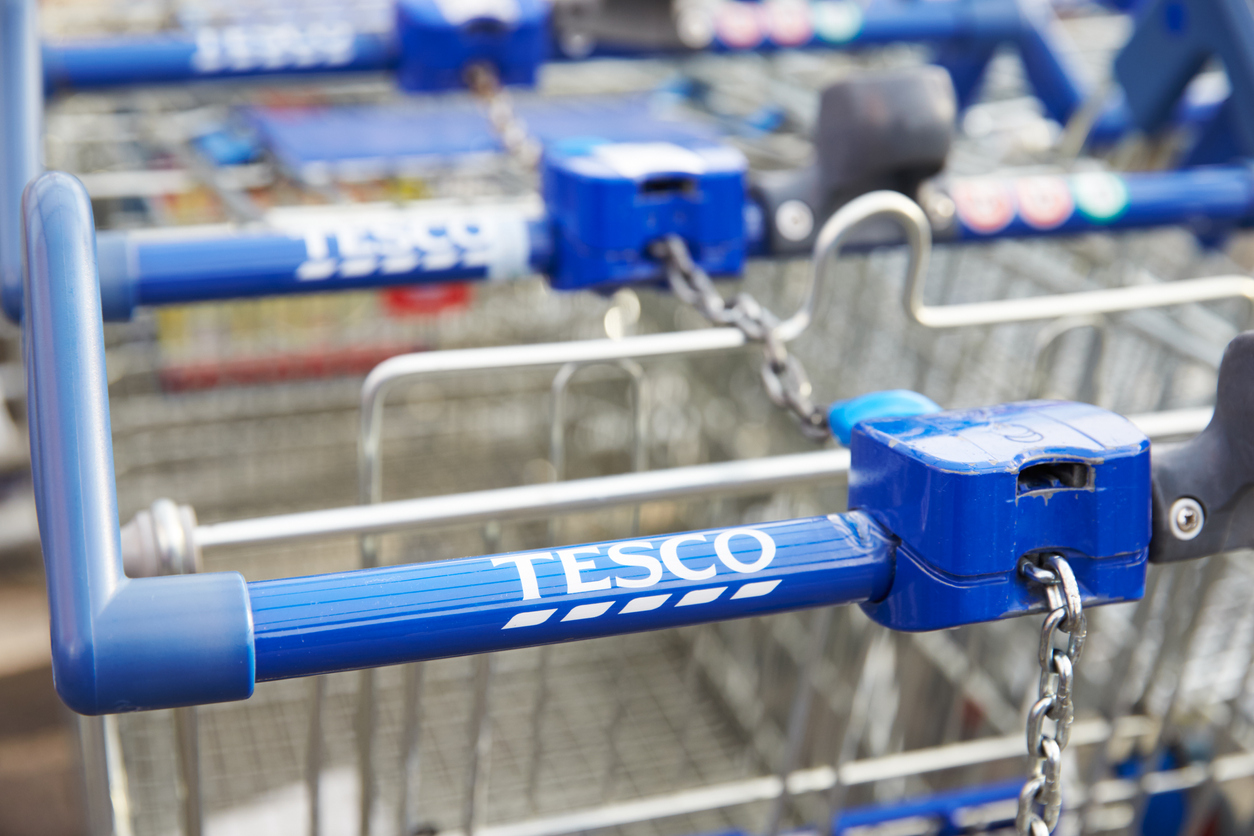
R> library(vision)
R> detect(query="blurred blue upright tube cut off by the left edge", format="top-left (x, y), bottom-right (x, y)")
top-left (0, 0), bottom-right (44, 321)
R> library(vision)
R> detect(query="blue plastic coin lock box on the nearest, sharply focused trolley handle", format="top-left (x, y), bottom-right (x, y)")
top-left (849, 401), bottom-right (1150, 630)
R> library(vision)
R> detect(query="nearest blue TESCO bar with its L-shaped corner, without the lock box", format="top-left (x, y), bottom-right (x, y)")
top-left (23, 173), bottom-right (893, 714)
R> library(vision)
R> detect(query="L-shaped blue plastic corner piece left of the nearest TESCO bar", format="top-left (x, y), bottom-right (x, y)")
top-left (21, 173), bottom-right (253, 714)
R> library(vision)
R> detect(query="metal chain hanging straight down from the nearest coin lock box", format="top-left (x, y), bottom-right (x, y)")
top-left (1014, 554), bottom-right (1088, 836)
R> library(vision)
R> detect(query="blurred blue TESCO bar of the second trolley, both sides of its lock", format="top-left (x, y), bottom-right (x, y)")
top-left (75, 165), bottom-right (1254, 320)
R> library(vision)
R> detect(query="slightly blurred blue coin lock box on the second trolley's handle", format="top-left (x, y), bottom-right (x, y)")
top-left (543, 139), bottom-right (749, 290)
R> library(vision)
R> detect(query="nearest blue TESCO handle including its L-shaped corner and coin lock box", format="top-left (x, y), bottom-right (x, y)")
top-left (23, 172), bottom-right (1150, 713)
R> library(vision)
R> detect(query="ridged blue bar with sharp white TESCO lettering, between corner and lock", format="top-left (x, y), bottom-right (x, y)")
top-left (248, 513), bottom-right (894, 681)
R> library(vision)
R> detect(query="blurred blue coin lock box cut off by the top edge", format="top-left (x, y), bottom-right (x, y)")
top-left (396, 0), bottom-right (549, 93)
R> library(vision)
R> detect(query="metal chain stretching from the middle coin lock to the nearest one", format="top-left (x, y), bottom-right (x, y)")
top-left (650, 234), bottom-right (831, 441)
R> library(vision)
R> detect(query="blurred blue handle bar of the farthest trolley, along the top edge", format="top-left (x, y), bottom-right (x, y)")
top-left (44, 0), bottom-right (1085, 120)
